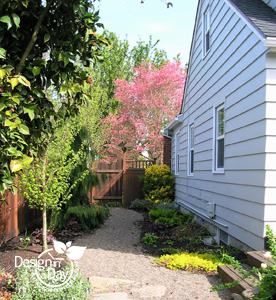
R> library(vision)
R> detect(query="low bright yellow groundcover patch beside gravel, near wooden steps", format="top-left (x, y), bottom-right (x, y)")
top-left (154, 252), bottom-right (224, 271)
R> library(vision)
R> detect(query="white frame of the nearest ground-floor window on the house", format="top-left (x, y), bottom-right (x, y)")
top-left (213, 100), bottom-right (225, 174)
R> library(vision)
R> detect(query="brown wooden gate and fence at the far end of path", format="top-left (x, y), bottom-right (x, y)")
top-left (88, 156), bottom-right (156, 207)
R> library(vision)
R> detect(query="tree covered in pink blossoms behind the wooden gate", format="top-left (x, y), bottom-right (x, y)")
top-left (102, 62), bottom-right (186, 162)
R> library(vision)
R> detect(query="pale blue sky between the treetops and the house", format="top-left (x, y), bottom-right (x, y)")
top-left (95, 0), bottom-right (197, 63)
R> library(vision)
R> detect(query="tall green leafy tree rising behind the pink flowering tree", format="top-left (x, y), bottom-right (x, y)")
top-left (90, 31), bottom-right (168, 116)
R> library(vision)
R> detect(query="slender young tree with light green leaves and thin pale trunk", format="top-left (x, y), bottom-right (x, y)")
top-left (19, 118), bottom-right (88, 251)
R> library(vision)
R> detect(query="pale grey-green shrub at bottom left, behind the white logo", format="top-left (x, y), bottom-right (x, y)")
top-left (12, 265), bottom-right (91, 300)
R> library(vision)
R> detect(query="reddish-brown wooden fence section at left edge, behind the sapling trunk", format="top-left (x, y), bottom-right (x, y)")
top-left (0, 192), bottom-right (41, 242)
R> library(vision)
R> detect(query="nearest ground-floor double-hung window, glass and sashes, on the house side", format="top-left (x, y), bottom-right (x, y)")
top-left (214, 104), bottom-right (225, 172)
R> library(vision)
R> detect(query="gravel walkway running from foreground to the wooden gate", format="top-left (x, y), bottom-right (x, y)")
top-left (74, 208), bottom-right (231, 300)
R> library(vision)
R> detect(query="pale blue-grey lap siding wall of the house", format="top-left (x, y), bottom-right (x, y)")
top-left (172, 0), bottom-right (270, 249)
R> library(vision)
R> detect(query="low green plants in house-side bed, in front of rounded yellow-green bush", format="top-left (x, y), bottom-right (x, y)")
top-left (149, 208), bottom-right (193, 226)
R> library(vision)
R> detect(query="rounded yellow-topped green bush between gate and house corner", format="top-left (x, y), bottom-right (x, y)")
top-left (141, 165), bottom-right (174, 202)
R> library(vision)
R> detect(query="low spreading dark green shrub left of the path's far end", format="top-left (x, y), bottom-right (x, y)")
top-left (64, 205), bottom-right (109, 230)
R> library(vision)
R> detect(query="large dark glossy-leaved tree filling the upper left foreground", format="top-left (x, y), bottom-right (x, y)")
top-left (0, 0), bottom-right (108, 195)
